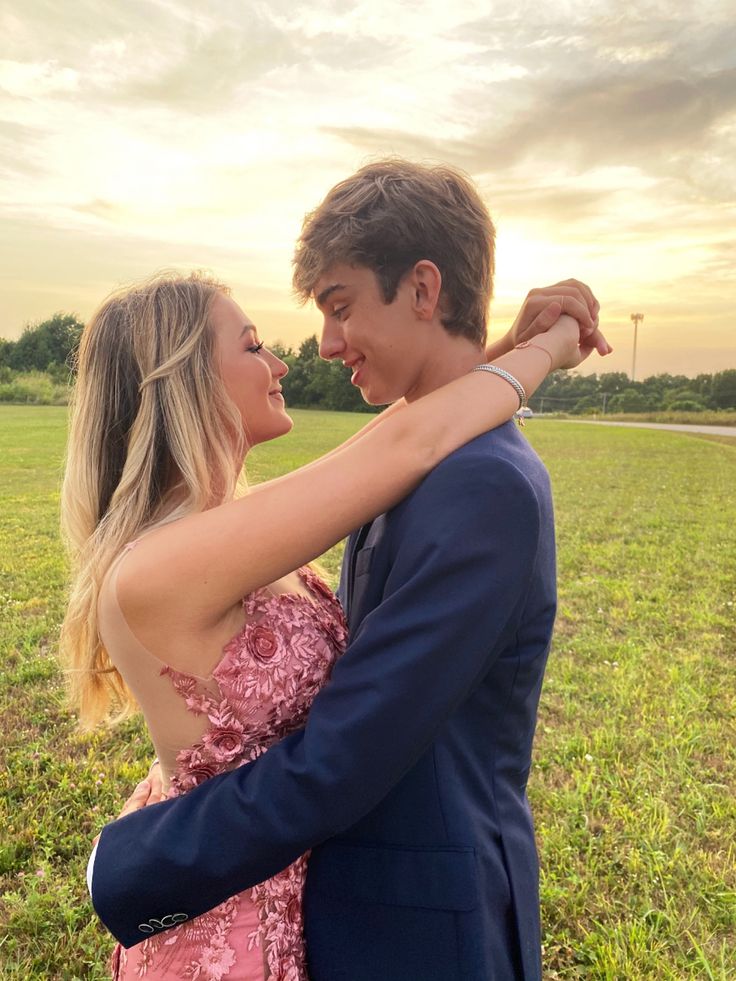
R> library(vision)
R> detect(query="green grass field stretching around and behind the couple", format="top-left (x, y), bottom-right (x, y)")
top-left (0, 406), bottom-right (736, 981)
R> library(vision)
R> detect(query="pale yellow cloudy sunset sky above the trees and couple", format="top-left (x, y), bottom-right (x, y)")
top-left (0, 0), bottom-right (736, 378)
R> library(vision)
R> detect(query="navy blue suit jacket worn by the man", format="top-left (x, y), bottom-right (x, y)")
top-left (92, 423), bottom-right (555, 981)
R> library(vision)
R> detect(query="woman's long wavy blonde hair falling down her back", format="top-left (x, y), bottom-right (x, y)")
top-left (60, 273), bottom-right (244, 729)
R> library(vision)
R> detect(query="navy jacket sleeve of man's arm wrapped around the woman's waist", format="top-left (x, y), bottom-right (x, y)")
top-left (92, 455), bottom-right (540, 946)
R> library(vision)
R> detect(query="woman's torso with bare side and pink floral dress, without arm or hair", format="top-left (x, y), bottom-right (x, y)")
top-left (98, 543), bottom-right (346, 981)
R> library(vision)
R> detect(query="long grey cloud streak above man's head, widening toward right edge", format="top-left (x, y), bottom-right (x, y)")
top-left (328, 69), bottom-right (736, 184)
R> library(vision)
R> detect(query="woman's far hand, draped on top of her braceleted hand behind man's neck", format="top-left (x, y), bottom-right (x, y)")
top-left (486, 279), bottom-right (613, 360)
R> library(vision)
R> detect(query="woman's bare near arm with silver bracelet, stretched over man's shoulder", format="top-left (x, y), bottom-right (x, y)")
top-left (118, 318), bottom-right (580, 629)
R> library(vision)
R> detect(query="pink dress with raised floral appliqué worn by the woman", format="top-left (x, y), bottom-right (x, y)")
top-left (112, 568), bottom-right (347, 981)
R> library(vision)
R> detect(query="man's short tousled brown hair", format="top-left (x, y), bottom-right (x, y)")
top-left (293, 158), bottom-right (495, 344)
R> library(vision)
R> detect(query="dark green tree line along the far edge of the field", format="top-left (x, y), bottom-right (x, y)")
top-left (0, 313), bottom-right (736, 415)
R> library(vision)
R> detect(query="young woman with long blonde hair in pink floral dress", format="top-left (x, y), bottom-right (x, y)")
top-left (62, 276), bottom-right (592, 981)
